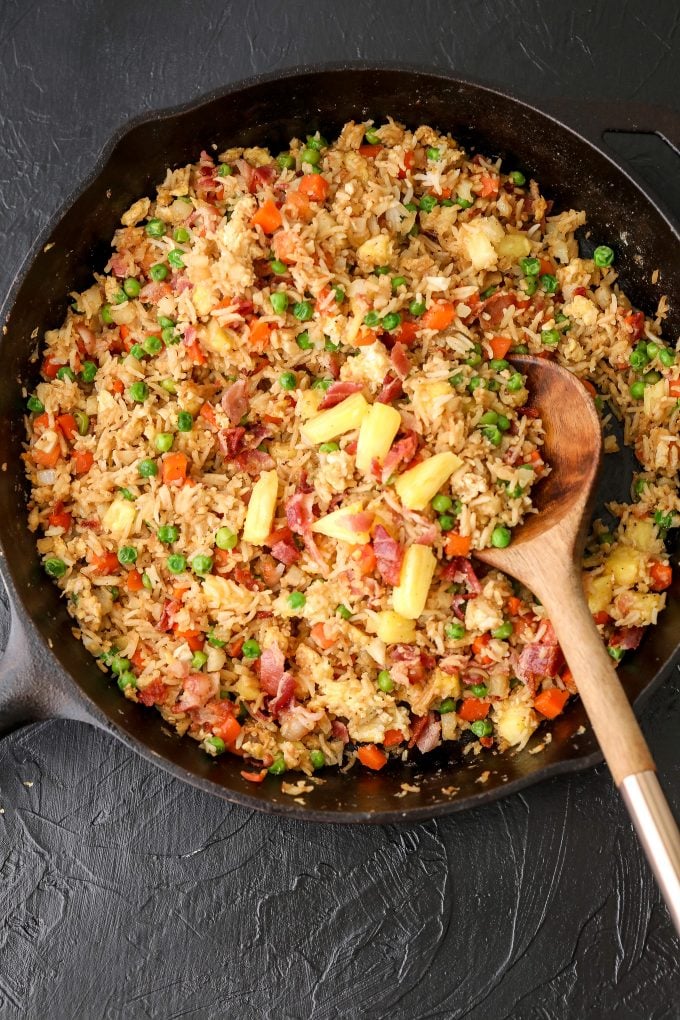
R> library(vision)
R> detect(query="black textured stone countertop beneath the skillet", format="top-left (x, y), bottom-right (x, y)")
top-left (0, 0), bottom-right (680, 1020)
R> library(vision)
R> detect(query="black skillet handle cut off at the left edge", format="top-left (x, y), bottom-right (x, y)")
top-left (0, 600), bottom-right (93, 736)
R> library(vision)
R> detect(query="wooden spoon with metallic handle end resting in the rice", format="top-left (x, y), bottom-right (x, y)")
top-left (475, 357), bottom-right (680, 932)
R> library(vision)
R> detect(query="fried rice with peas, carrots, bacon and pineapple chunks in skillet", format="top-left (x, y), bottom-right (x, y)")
top-left (24, 120), bottom-right (680, 781)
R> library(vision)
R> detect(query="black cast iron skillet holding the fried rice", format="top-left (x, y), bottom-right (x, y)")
top-left (0, 65), bottom-right (680, 822)
